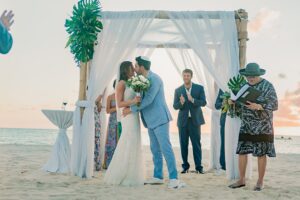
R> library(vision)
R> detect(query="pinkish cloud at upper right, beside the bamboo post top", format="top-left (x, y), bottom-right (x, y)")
top-left (248, 9), bottom-right (280, 34)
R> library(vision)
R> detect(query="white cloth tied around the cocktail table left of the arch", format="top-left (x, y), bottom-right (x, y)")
top-left (42, 110), bottom-right (73, 173)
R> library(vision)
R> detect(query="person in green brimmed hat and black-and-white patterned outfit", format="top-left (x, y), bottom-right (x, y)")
top-left (229, 63), bottom-right (278, 191)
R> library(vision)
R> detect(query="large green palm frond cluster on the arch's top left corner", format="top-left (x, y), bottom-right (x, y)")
top-left (65, 0), bottom-right (103, 64)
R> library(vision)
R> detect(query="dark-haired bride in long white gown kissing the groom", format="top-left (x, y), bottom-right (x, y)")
top-left (104, 61), bottom-right (144, 186)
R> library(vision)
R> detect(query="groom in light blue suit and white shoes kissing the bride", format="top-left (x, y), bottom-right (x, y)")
top-left (123, 56), bottom-right (185, 189)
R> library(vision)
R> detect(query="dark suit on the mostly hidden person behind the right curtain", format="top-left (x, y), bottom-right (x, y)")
top-left (215, 90), bottom-right (227, 170)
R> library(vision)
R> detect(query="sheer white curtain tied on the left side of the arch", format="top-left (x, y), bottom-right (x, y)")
top-left (71, 11), bottom-right (157, 178)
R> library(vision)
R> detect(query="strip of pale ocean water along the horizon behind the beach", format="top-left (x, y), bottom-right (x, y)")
top-left (0, 127), bottom-right (300, 154)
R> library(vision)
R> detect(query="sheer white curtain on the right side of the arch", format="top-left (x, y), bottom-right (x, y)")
top-left (168, 11), bottom-right (251, 179)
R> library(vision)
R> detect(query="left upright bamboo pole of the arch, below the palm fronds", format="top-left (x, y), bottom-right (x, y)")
top-left (78, 62), bottom-right (88, 119)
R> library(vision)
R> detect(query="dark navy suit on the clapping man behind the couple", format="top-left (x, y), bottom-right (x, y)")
top-left (173, 83), bottom-right (206, 170)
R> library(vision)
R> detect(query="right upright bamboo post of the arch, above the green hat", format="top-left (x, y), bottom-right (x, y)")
top-left (235, 9), bottom-right (248, 68)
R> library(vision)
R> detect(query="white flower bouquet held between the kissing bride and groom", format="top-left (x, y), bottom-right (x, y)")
top-left (127, 75), bottom-right (151, 106)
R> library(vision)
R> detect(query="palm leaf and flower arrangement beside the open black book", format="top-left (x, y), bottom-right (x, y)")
top-left (221, 75), bottom-right (247, 118)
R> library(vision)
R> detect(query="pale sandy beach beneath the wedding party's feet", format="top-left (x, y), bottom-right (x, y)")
top-left (0, 145), bottom-right (300, 200)
